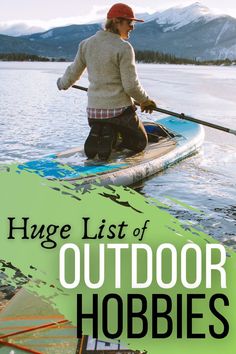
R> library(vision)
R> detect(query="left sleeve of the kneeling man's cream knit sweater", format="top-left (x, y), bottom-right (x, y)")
top-left (60, 43), bottom-right (86, 90)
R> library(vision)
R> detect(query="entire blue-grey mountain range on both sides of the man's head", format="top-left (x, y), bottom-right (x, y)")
top-left (0, 2), bottom-right (236, 60)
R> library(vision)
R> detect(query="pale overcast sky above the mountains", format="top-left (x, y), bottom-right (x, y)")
top-left (0, 0), bottom-right (236, 27)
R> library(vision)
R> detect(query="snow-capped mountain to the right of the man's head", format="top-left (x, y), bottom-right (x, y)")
top-left (131, 2), bottom-right (236, 60)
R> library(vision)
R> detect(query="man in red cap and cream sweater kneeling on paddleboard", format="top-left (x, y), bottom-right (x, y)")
top-left (57, 3), bottom-right (156, 160)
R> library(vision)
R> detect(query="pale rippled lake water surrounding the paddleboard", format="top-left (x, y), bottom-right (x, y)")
top-left (0, 62), bottom-right (236, 246)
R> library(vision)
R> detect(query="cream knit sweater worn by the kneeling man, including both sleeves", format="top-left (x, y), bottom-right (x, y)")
top-left (58, 30), bottom-right (148, 109)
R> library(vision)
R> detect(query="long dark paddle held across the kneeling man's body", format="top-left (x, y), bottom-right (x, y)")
top-left (72, 85), bottom-right (236, 135)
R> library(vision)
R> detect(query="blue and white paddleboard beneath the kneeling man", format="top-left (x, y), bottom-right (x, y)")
top-left (18, 117), bottom-right (204, 186)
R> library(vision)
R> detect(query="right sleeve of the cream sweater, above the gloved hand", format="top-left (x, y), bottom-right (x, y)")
top-left (120, 43), bottom-right (148, 103)
